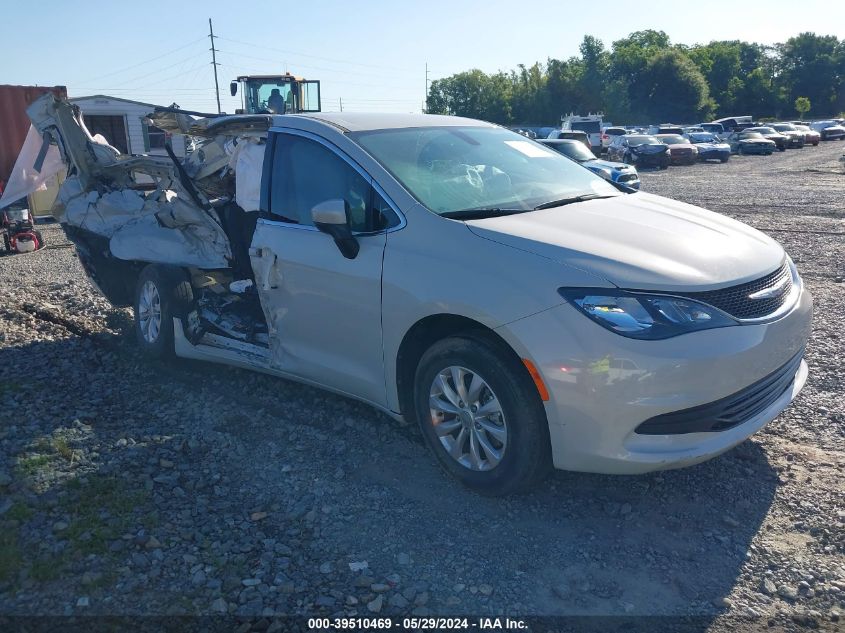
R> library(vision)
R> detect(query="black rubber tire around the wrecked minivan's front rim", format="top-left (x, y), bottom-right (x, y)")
top-left (414, 337), bottom-right (552, 496)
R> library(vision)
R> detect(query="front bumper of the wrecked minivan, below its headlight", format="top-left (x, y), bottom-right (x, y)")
top-left (497, 287), bottom-right (813, 474)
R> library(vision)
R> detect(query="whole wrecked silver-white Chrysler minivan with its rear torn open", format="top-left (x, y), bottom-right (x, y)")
top-left (29, 95), bottom-right (812, 494)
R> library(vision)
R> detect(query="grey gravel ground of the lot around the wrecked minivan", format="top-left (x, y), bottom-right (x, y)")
top-left (0, 142), bottom-right (845, 631)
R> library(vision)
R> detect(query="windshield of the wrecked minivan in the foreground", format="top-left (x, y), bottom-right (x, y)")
top-left (350, 127), bottom-right (621, 214)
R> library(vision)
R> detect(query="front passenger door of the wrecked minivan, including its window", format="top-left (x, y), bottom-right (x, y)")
top-left (250, 130), bottom-right (398, 404)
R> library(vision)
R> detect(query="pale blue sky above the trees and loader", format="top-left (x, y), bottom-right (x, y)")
top-left (0, 0), bottom-right (845, 112)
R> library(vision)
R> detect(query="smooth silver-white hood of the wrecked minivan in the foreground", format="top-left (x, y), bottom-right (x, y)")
top-left (467, 193), bottom-right (784, 291)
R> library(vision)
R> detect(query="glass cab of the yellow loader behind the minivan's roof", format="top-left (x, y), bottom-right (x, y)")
top-left (229, 73), bottom-right (320, 114)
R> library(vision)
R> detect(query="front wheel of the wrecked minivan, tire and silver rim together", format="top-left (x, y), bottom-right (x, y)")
top-left (414, 337), bottom-right (552, 496)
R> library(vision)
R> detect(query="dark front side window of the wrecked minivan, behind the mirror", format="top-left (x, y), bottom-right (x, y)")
top-left (270, 134), bottom-right (371, 231)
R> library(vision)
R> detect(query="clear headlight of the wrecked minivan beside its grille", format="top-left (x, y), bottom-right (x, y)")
top-left (558, 288), bottom-right (738, 340)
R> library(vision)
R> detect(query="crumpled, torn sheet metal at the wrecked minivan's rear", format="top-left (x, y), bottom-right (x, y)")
top-left (27, 95), bottom-right (235, 268)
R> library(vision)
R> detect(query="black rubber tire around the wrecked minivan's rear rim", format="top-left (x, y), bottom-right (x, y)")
top-left (132, 264), bottom-right (194, 358)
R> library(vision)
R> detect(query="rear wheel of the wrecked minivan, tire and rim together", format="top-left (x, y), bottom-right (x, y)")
top-left (133, 264), bottom-right (193, 358)
